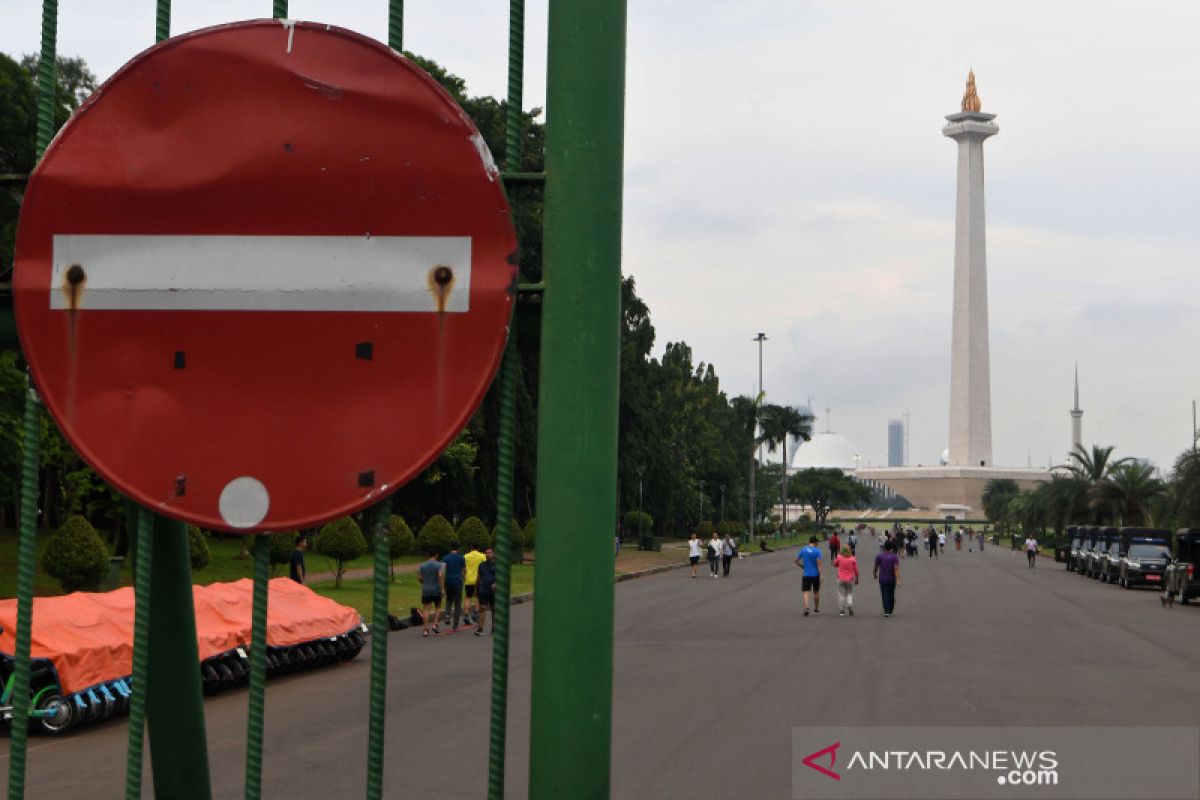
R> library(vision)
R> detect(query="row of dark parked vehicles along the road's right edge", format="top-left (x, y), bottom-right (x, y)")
top-left (1056, 525), bottom-right (1200, 603)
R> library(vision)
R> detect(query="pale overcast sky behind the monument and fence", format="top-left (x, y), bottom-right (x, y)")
top-left (0, 0), bottom-right (1200, 467)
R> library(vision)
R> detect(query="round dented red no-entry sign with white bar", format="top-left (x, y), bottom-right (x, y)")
top-left (14, 20), bottom-right (516, 530)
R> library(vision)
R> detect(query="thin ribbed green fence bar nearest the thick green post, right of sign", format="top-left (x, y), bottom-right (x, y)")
top-left (487, 0), bottom-right (524, 800)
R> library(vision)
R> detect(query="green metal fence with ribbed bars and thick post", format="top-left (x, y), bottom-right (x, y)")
top-left (5, 0), bottom-right (625, 800)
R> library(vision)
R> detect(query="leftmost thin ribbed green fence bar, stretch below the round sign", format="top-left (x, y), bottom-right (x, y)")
top-left (8, 386), bottom-right (42, 800)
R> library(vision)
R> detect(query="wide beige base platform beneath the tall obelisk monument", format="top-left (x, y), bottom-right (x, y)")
top-left (854, 467), bottom-right (1051, 517)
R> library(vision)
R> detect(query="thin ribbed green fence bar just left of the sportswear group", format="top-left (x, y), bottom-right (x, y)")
top-left (367, 498), bottom-right (391, 800)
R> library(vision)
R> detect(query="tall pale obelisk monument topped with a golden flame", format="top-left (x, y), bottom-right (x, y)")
top-left (942, 71), bottom-right (1000, 467)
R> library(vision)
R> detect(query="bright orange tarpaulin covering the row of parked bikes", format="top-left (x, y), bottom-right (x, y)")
top-left (0, 578), bottom-right (361, 694)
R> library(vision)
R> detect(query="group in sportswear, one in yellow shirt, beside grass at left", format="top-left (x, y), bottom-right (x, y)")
top-left (416, 545), bottom-right (496, 636)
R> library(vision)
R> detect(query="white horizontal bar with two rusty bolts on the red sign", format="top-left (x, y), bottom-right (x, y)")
top-left (50, 234), bottom-right (470, 313)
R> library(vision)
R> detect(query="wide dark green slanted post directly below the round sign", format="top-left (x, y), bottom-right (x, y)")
top-left (146, 515), bottom-right (212, 800)
